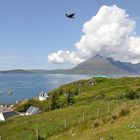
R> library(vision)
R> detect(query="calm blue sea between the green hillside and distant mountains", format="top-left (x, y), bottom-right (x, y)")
top-left (0, 74), bottom-right (91, 104)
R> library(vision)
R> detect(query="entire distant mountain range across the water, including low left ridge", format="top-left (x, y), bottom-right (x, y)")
top-left (0, 55), bottom-right (140, 75)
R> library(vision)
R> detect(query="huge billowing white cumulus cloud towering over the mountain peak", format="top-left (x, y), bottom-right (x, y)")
top-left (48, 5), bottom-right (140, 64)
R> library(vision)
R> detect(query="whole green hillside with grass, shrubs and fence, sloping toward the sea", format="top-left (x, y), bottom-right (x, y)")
top-left (0, 77), bottom-right (140, 140)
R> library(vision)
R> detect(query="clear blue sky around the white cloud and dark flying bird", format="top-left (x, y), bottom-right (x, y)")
top-left (0, 0), bottom-right (140, 70)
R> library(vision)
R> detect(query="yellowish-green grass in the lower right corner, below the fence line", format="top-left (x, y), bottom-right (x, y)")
top-left (49, 102), bottom-right (140, 140)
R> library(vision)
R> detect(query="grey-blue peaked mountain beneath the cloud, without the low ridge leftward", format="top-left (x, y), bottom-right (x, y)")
top-left (68, 55), bottom-right (140, 75)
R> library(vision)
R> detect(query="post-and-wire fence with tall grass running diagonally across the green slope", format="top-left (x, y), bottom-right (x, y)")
top-left (33, 100), bottom-right (140, 140)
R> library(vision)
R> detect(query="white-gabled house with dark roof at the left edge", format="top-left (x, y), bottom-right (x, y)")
top-left (0, 111), bottom-right (18, 121)
